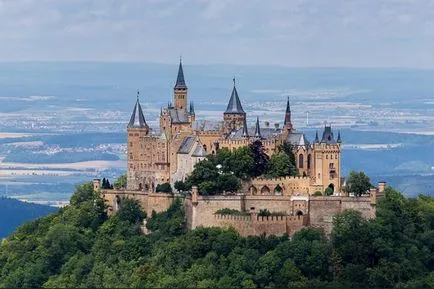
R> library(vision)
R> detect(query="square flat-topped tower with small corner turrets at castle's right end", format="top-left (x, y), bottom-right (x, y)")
top-left (313, 126), bottom-right (342, 192)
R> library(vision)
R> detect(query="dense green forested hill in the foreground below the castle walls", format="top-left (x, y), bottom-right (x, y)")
top-left (0, 184), bottom-right (434, 289)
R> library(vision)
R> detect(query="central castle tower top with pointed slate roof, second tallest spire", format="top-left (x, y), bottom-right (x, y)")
top-left (223, 77), bottom-right (246, 133)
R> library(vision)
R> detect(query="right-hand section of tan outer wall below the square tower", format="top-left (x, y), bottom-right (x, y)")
top-left (309, 196), bottom-right (375, 234)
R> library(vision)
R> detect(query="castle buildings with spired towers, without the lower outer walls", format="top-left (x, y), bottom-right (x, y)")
top-left (127, 62), bottom-right (342, 194)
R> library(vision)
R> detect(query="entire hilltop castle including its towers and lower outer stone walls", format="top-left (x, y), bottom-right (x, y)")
top-left (94, 62), bottom-right (385, 236)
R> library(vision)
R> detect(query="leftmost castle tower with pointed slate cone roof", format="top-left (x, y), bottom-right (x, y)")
top-left (127, 92), bottom-right (149, 187)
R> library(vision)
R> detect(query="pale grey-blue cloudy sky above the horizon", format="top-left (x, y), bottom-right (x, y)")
top-left (0, 0), bottom-right (434, 68)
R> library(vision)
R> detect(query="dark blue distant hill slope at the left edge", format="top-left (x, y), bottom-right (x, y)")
top-left (0, 197), bottom-right (57, 239)
